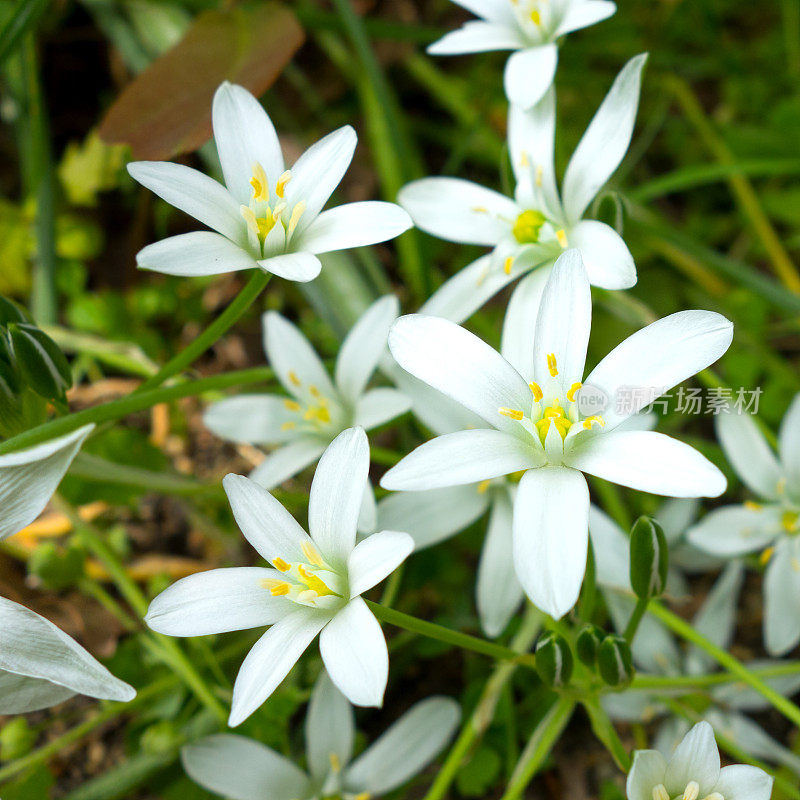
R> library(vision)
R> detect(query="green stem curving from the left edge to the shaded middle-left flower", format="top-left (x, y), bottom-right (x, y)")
top-left (0, 367), bottom-right (274, 454)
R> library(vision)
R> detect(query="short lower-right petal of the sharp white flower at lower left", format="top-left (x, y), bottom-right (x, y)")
top-left (319, 597), bottom-right (389, 706)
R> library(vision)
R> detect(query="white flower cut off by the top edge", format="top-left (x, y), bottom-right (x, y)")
top-left (428, 0), bottom-right (617, 108)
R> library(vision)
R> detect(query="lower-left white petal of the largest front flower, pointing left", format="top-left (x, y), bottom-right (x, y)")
top-left (381, 428), bottom-right (544, 492)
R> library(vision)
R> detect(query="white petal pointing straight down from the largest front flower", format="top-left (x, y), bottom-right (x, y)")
top-left (514, 467), bottom-right (589, 619)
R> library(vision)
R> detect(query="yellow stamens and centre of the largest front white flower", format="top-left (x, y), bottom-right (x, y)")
top-left (497, 353), bottom-right (606, 448)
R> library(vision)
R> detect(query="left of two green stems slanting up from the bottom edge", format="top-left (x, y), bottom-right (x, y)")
top-left (423, 604), bottom-right (542, 800)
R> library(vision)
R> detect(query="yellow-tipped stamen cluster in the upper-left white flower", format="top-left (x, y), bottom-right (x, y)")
top-left (239, 161), bottom-right (306, 255)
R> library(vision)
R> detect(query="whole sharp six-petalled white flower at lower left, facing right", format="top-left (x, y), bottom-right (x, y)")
top-left (146, 428), bottom-right (414, 726)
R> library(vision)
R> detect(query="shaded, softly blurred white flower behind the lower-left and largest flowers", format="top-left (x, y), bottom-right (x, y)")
top-left (203, 295), bottom-right (411, 495)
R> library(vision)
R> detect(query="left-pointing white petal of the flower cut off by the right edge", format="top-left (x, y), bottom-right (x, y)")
top-left (686, 506), bottom-right (782, 557)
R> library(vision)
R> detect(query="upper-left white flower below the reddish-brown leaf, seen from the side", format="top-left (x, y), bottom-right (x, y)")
top-left (128, 82), bottom-right (411, 281)
